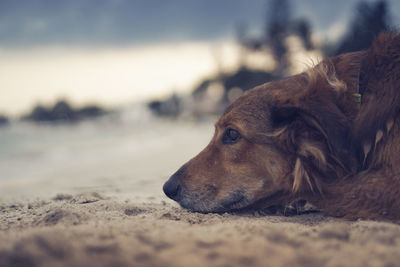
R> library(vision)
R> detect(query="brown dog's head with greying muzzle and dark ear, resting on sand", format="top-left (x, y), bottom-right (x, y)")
top-left (163, 52), bottom-right (364, 212)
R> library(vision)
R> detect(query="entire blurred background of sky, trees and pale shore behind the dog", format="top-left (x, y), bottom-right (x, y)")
top-left (0, 0), bottom-right (400, 199)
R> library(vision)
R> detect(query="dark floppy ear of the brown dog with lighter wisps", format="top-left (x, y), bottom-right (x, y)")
top-left (271, 107), bottom-right (346, 192)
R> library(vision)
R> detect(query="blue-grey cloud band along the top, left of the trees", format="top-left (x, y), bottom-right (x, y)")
top-left (0, 0), bottom-right (265, 46)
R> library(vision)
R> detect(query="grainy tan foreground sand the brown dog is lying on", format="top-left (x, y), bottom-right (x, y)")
top-left (0, 192), bottom-right (400, 266)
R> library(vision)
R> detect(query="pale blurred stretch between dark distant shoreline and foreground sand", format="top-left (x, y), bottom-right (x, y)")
top-left (0, 105), bottom-right (213, 202)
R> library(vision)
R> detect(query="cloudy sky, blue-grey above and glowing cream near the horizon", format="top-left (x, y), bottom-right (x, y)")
top-left (0, 0), bottom-right (400, 115)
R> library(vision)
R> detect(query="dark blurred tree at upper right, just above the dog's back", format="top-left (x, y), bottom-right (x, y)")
top-left (327, 0), bottom-right (391, 56)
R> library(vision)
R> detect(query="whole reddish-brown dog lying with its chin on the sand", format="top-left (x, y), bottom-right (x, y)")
top-left (163, 33), bottom-right (400, 222)
